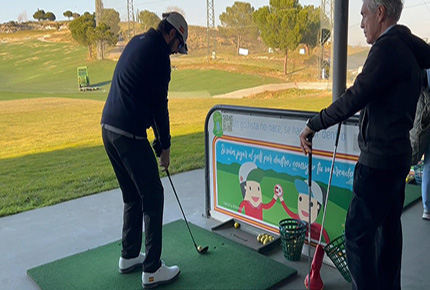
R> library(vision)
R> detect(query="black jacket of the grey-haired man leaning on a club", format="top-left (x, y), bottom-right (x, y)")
top-left (308, 25), bottom-right (430, 168)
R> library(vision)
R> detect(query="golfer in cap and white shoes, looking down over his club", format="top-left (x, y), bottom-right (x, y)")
top-left (101, 12), bottom-right (188, 288)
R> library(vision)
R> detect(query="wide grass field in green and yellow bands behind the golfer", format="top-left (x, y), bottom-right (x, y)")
top-left (0, 32), bottom-right (331, 216)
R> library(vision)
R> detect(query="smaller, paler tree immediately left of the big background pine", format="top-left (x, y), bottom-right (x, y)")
top-left (219, 2), bottom-right (258, 54)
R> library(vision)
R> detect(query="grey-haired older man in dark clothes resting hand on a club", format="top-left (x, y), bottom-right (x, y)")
top-left (300, 0), bottom-right (430, 290)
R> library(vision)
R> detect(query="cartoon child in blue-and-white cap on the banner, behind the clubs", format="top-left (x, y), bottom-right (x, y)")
top-left (279, 179), bottom-right (330, 244)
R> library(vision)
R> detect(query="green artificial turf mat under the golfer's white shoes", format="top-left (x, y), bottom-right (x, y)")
top-left (27, 220), bottom-right (296, 290)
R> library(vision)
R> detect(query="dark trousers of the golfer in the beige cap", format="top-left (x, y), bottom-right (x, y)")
top-left (102, 128), bottom-right (164, 272)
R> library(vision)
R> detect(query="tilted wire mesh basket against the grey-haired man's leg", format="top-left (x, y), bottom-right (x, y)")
top-left (324, 235), bottom-right (351, 283)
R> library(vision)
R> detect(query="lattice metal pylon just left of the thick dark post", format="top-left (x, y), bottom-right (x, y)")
top-left (318, 0), bottom-right (335, 79)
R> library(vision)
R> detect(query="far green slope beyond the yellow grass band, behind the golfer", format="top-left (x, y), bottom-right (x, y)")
top-left (0, 40), bottom-right (282, 100)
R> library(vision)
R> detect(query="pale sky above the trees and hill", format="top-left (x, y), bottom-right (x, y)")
top-left (0, 0), bottom-right (430, 45)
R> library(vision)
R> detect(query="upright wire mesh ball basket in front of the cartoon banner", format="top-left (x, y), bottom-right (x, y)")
top-left (279, 219), bottom-right (307, 261)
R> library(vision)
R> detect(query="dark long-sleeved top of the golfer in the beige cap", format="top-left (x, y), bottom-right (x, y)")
top-left (101, 28), bottom-right (171, 149)
